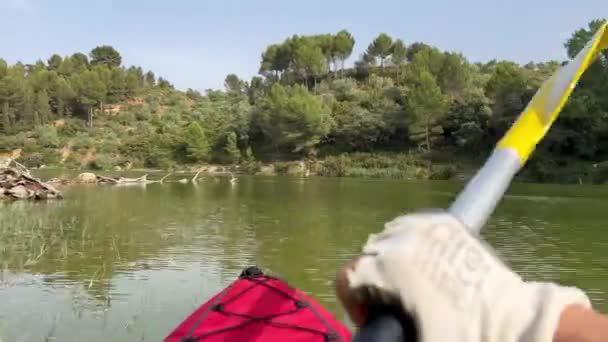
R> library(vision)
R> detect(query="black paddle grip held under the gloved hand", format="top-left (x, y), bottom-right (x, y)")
top-left (353, 306), bottom-right (418, 342)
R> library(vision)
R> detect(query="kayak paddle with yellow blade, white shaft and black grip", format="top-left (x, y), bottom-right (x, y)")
top-left (354, 22), bottom-right (608, 342)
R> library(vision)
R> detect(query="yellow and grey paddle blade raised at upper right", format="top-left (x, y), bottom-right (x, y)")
top-left (497, 22), bottom-right (608, 165)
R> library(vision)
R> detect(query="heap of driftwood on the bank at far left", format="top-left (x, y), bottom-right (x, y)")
top-left (0, 164), bottom-right (63, 200)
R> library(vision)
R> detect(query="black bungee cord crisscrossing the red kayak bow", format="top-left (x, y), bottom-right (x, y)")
top-left (180, 266), bottom-right (345, 342)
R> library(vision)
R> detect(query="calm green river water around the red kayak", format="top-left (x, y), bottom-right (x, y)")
top-left (0, 177), bottom-right (608, 342)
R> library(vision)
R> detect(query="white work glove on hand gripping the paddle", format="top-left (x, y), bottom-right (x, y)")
top-left (347, 213), bottom-right (591, 342)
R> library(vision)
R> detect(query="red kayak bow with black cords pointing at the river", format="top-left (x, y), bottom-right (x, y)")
top-left (165, 267), bottom-right (352, 342)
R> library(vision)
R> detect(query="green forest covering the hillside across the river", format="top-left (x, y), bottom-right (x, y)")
top-left (0, 20), bottom-right (608, 180)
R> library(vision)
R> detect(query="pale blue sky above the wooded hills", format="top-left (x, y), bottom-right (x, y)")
top-left (0, 0), bottom-right (608, 90)
